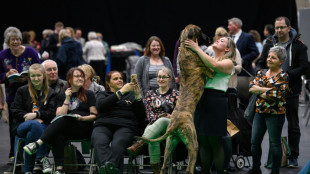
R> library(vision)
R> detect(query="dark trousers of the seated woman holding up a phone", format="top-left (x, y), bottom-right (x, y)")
top-left (91, 125), bottom-right (136, 173)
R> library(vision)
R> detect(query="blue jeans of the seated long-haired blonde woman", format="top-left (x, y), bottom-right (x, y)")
top-left (17, 120), bottom-right (49, 172)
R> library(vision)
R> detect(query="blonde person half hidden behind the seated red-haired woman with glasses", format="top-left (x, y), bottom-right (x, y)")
top-left (78, 64), bottom-right (105, 96)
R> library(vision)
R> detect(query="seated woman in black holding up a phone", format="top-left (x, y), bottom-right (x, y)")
top-left (91, 71), bottom-right (145, 174)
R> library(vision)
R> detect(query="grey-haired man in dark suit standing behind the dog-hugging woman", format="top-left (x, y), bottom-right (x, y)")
top-left (227, 17), bottom-right (259, 110)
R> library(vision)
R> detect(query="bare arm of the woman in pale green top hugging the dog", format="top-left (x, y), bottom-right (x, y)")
top-left (185, 40), bottom-right (234, 74)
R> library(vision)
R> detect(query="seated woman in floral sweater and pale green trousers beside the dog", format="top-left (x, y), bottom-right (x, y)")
top-left (127, 67), bottom-right (179, 174)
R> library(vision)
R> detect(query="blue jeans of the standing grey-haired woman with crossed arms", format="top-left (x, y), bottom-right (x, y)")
top-left (251, 113), bottom-right (285, 170)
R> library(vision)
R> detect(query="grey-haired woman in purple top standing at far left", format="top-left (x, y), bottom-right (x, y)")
top-left (0, 27), bottom-right (41, 163)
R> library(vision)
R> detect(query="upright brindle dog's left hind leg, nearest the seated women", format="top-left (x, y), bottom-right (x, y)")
top-left (160, 135), bottom-right (180, 174)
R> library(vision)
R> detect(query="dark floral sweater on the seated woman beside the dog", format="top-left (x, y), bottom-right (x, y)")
top-left (143, 88), bottom-right (179, 124)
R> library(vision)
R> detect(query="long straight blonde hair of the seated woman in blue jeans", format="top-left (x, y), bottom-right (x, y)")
top-left (28, 63), bottom-right (49, 102)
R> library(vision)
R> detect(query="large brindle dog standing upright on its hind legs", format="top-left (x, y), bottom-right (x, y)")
top-left (137, 24), bottom-right (215, 174)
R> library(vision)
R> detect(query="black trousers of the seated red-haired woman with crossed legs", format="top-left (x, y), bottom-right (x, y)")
top-left (40, 117), bottom-right (92, 167)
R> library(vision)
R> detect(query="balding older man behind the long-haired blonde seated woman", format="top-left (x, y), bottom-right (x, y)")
top-left (42, 59), bottom-right (67, 94)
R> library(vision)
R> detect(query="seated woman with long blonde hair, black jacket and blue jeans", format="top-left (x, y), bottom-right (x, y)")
top-left (11, 63), bottom-right (56, 174)
